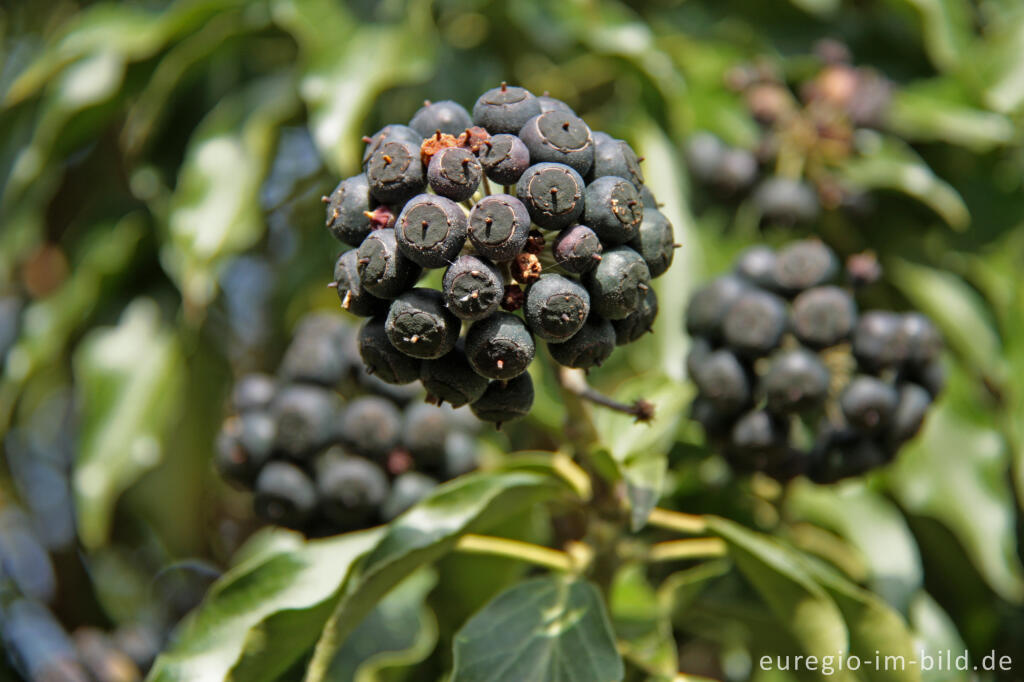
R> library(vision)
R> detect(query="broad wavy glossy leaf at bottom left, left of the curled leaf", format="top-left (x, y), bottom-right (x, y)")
top-left (146, 528), bottom-right (382, 682)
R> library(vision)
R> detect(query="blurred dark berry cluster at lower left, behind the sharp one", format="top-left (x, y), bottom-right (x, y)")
top-left (215, 313), bottom-right (477, 536)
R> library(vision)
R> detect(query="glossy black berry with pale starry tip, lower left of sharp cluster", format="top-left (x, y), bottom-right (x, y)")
top-left (384, 288), bottom-right (462, 359)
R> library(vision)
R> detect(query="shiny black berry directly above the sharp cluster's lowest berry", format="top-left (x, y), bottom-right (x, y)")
top-left (466, 312), bottom-right (536, 380)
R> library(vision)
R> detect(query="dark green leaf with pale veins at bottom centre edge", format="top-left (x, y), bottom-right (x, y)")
top-left (452, 577), bottom-right (626, 682)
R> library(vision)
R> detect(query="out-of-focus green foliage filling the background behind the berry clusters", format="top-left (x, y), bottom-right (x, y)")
top-left (0, 0), bottom-right (1024, 679)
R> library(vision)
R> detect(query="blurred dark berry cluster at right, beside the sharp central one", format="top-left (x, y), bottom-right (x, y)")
top-left (686, 240), bottom-right (943, 483)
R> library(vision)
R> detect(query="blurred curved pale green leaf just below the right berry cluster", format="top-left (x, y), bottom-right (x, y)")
top-left (785, 480), bottom-right (924, 611)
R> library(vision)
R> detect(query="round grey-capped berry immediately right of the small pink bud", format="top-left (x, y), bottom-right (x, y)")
top-left (395, 193), bottom-right (468, 267)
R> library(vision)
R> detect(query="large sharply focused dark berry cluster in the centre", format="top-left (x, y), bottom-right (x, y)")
top-left (325, 84), bottom-right (676, 425)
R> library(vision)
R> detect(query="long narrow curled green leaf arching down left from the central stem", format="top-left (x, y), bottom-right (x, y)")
top-left (306, 472), bottom-right (567, 682)
